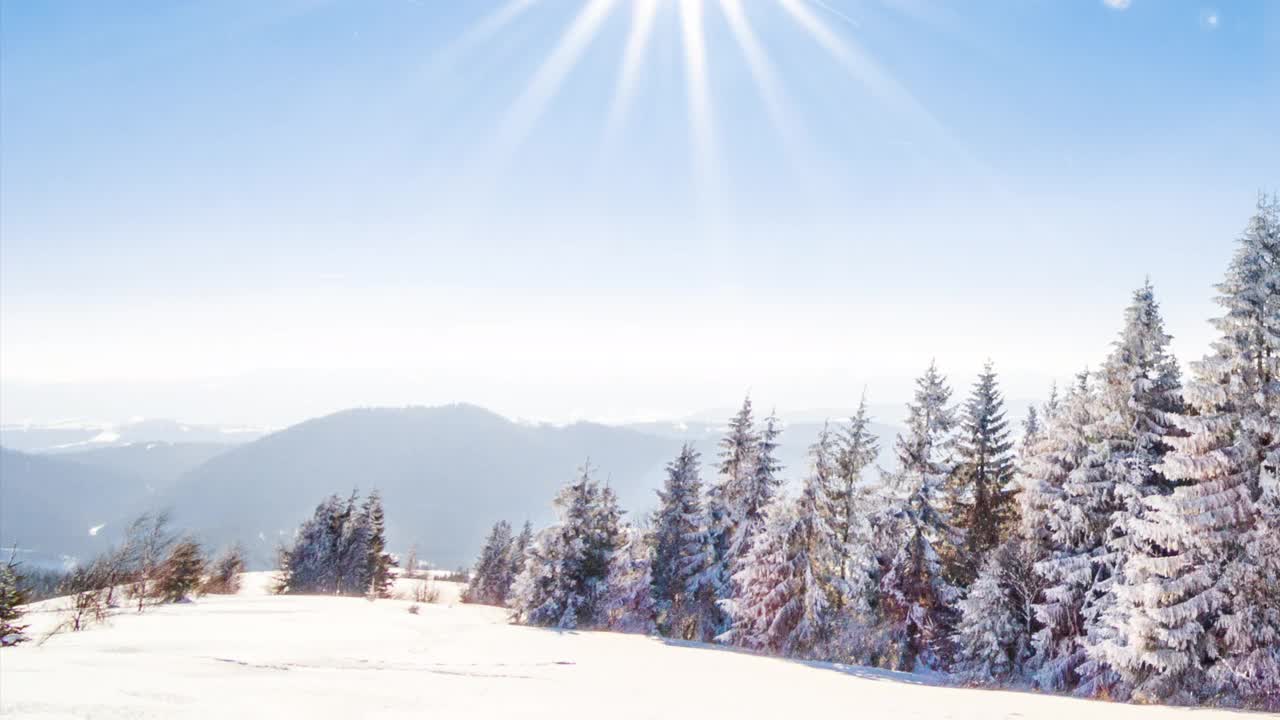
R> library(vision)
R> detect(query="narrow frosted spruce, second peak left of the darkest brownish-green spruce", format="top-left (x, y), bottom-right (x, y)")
top-left (829, 395), bottom-right (882, 615)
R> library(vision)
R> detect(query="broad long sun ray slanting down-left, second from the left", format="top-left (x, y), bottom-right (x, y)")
top-left (494, 0), bottom-right (616, 155)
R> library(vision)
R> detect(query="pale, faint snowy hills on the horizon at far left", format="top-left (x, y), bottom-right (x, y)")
top-left (0, 419), bottom-right (266, 452)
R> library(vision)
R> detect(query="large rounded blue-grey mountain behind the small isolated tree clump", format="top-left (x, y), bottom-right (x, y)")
top-left (157, 405), bottom-right (680, 566)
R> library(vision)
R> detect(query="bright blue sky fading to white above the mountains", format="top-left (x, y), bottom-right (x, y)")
top-left (0, 0), bottom-right (1280, 424)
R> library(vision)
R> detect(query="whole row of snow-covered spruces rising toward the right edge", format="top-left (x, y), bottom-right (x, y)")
top-left (468, 197), bottom-right (1280, 708)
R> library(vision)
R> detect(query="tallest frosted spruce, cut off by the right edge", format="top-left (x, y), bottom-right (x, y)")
top-left (1152, 197), bottom-right (1280, 710)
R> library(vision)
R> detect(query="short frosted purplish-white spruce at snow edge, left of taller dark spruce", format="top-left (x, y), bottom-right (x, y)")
top-left (598, 525), bottom-right (658, 634)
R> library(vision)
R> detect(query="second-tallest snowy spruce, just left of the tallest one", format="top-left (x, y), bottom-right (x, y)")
top-left (1076, 282), bottom-right (1183, 698)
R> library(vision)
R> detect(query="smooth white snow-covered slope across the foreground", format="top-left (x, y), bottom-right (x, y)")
top-left (0, 573), bottom-right (1249, 720)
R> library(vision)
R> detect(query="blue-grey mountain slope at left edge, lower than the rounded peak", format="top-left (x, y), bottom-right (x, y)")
top-left (0, 448), bottom-right (147, 564)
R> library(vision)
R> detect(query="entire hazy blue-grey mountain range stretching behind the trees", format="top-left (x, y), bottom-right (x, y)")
top-left (10, 405), bottom-right (911, 568)
